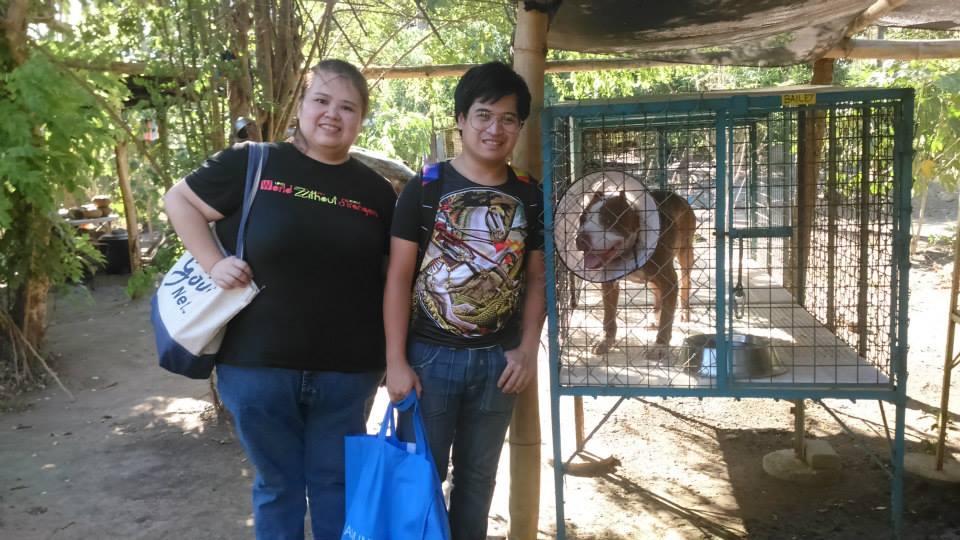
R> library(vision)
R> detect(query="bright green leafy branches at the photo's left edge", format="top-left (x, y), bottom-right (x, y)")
top-left (0, 49), bottom-right (120, 296)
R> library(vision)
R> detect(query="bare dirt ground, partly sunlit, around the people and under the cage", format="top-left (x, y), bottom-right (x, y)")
top-left (0, 185), bottom-right (960, 540)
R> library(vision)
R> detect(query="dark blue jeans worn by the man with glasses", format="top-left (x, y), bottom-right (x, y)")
top-left (399, 341), bottom-right (516, 540)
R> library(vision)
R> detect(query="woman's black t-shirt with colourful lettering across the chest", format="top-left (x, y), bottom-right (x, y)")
top-left (186, 143), bottom-right (396, 372)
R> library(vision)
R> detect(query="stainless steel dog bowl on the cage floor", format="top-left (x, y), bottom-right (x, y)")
top-left (682, 334), bottom-right (787, 379)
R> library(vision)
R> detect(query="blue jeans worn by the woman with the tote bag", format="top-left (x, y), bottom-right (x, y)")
top-left (217, 364), bottom-right (383, 540)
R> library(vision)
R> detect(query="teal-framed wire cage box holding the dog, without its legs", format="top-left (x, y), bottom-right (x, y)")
top-left (543, 88), bottom-right (912, 398)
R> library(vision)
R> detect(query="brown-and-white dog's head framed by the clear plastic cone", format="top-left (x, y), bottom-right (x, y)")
top-left (576, 191), bottom-right (641, 270)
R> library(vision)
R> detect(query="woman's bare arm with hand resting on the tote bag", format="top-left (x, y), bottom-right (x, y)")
top-left (163, 180), bottom-right (253, 289)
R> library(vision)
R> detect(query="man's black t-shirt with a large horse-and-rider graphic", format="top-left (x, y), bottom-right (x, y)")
top-left (391, 163), bottom-right (543, 349)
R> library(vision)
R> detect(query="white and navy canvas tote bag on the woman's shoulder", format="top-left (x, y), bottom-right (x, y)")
top-left (150, 143), bottom-right (268, 379)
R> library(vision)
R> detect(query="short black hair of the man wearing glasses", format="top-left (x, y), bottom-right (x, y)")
top-left (453, 62), bottom-right (530, 120)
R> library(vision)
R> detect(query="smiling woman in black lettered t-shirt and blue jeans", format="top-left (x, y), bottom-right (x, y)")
top-left (164, 60), bottom-right (396, 540)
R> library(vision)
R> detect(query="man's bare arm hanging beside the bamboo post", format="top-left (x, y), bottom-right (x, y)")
top-left (497, 250), bottom-right (547, 394)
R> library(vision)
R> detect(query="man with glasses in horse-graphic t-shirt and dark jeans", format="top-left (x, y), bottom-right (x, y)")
top-left (384, 62), bottom-right (544, 540)
